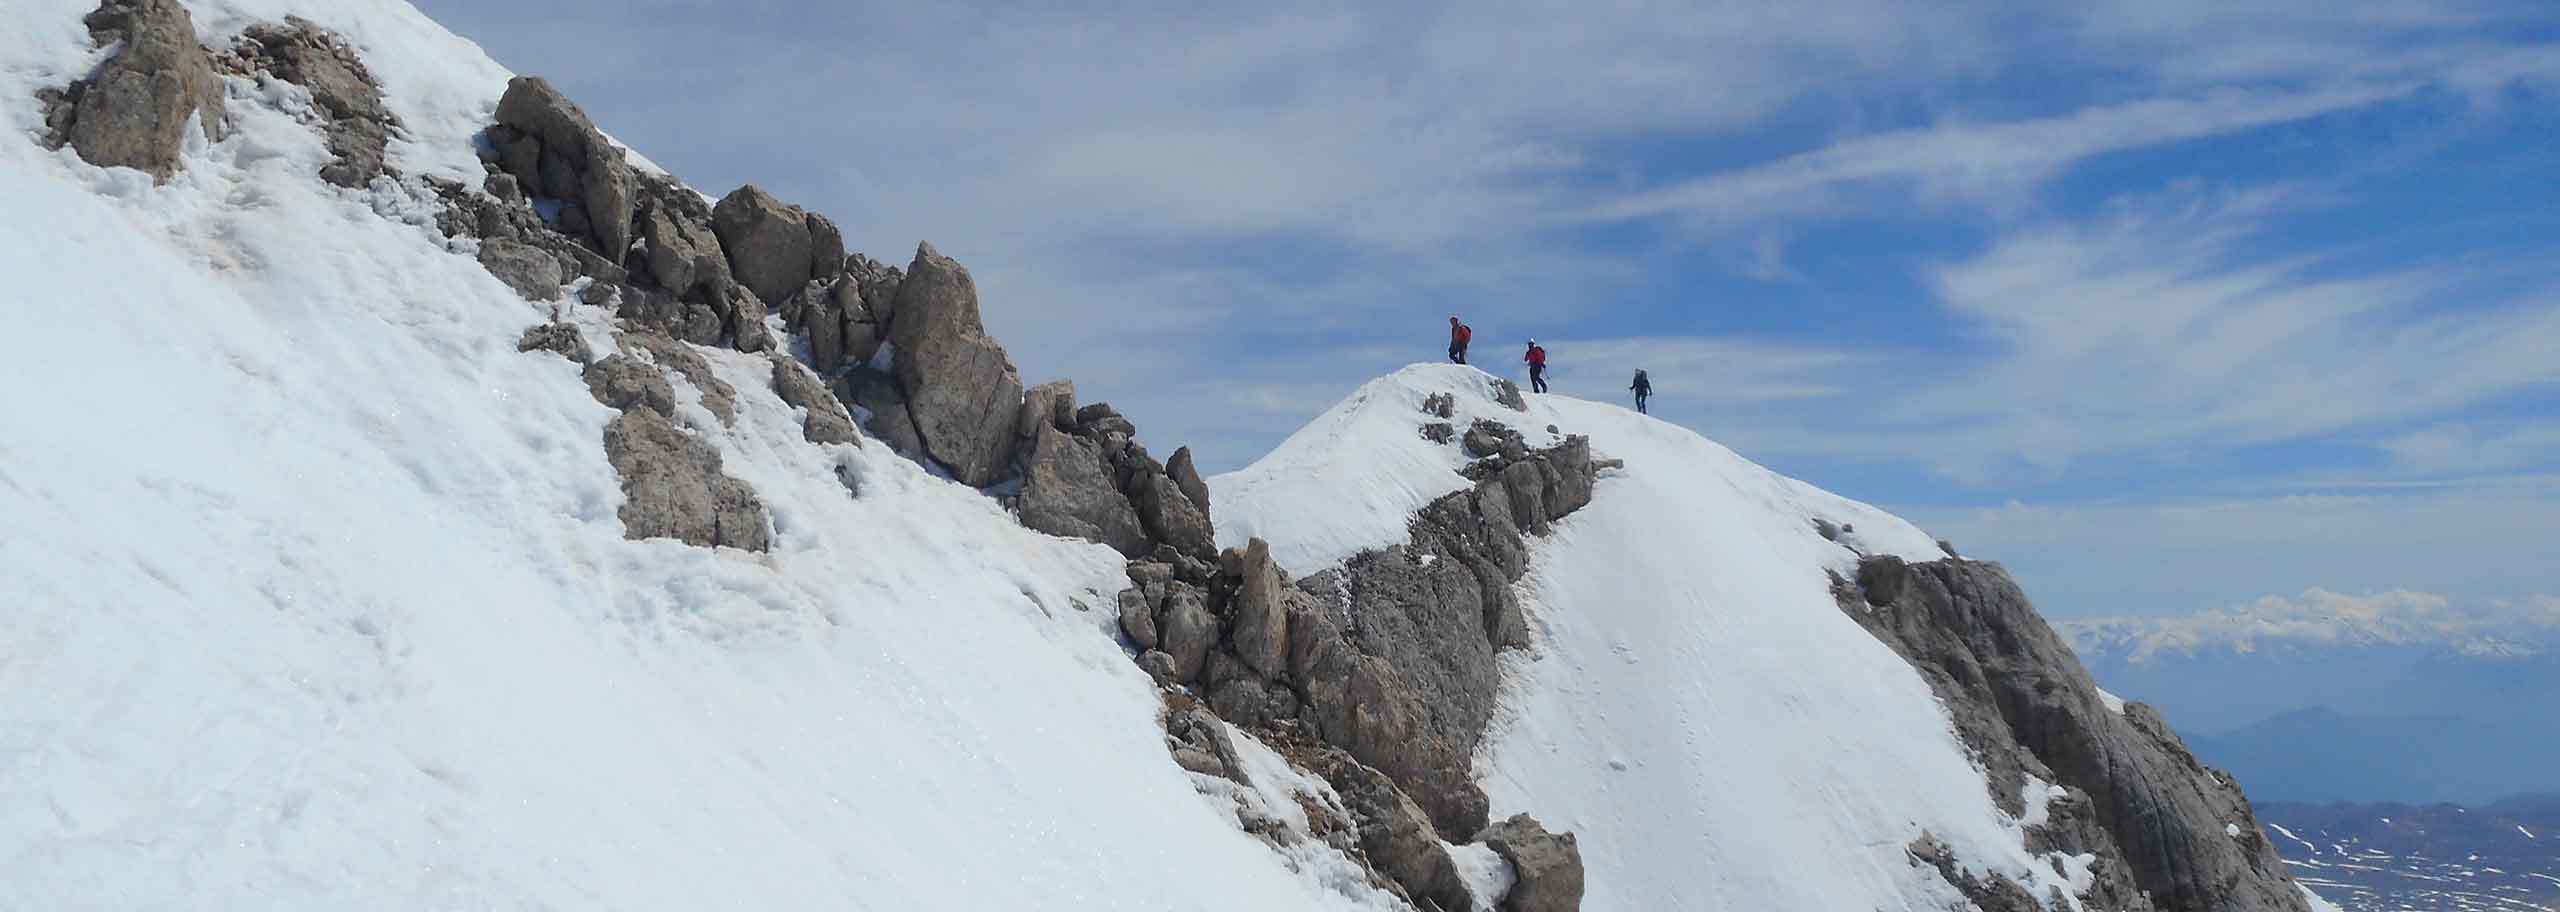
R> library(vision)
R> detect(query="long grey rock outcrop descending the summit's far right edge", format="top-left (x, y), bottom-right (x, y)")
top-left (1836, 556), bottom-right (2307, 912)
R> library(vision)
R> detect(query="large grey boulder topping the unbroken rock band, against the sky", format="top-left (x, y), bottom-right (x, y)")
top-left (492, 77), bottom-right (640, 261)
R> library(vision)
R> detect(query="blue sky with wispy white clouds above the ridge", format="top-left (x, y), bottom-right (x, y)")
top-left (422, 0), bottom-right (2560, 615)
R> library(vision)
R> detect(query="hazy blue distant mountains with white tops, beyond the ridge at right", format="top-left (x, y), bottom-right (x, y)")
top-left (2056, 589), bottom-right (2560, 804)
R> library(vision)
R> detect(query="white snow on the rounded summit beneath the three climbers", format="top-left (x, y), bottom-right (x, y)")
top-left (1211, 364), bottom-right (2109, 909)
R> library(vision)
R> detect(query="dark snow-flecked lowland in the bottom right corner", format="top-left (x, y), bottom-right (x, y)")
top-left (2255, 794), bottom-right (2560, 912)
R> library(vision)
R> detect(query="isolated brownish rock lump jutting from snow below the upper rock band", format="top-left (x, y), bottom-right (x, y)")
top-left (604, 410), bottom-right (771, 551)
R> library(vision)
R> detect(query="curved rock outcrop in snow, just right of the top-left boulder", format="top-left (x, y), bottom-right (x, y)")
top-left (236, 15), bottom-right (399, 187)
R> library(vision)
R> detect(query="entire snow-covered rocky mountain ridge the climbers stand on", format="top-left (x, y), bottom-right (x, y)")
top-left (0, 0), bottom-right (2344, 909)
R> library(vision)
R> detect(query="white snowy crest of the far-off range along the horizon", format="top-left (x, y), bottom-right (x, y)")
top-left (2056, 587), bottom-right (2560, 661)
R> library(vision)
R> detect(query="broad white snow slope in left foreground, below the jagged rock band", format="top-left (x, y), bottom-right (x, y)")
top-left (0, 0), bottom-right (1375, 909)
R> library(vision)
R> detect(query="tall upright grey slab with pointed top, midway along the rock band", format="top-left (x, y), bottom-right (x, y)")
top-left (888, 243), bottom-right (1021, 487)
